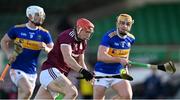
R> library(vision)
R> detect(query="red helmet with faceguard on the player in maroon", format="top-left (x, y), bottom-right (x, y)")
top-left (76, 18), bottom-right (94, 41)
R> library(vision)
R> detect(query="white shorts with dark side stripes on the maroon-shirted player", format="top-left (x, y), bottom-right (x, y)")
top-left (39, 68), bottom-right (63, 98)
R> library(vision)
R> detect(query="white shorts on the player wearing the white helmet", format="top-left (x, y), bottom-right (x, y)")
top-left (10, 69), bottom-right (37, 88)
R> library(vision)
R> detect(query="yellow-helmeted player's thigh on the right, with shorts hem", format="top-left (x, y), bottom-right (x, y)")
top-left (112, 79), bottom-right (133, 100)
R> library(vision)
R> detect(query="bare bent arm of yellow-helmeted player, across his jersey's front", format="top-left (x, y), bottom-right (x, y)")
top-left (97, 45), bottom-right (128, 65)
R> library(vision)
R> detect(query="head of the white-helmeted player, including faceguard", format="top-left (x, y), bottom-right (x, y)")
top-left (26, 6), bottom-right (45, 26)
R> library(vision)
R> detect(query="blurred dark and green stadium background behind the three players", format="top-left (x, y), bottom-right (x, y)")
top-left (0, 0), bottom-right (180, 99)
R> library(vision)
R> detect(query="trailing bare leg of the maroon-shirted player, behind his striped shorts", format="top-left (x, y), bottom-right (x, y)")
top-left (34, 86), bottom-right (53, 100)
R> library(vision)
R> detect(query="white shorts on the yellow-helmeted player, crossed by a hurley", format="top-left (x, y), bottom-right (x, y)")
top-left (94, 72), bottom-right (122, 88)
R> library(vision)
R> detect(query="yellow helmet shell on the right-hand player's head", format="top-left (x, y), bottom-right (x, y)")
top-left (117, 14), bottom-right (134, 24)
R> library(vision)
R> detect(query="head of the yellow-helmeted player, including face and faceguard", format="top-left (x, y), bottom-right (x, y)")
top-left (116, 14), bottom-right (134, 35)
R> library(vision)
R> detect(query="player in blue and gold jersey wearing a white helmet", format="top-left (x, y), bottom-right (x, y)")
top-left (1, 6), bottom-right (54, 99)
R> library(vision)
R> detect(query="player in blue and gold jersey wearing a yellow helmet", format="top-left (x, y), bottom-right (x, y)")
top-left (93, 14), bottom-right (135, 99)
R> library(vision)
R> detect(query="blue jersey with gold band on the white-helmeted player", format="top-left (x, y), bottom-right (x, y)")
top-left (7, 24), bottom-right (52, 74)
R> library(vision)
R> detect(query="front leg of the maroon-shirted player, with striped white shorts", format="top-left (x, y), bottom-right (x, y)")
top-left (39, 68), bottom-right (78, 99)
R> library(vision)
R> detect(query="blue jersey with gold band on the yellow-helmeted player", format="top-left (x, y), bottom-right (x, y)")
top-left (95, 29), bottom-right (135, 74)
